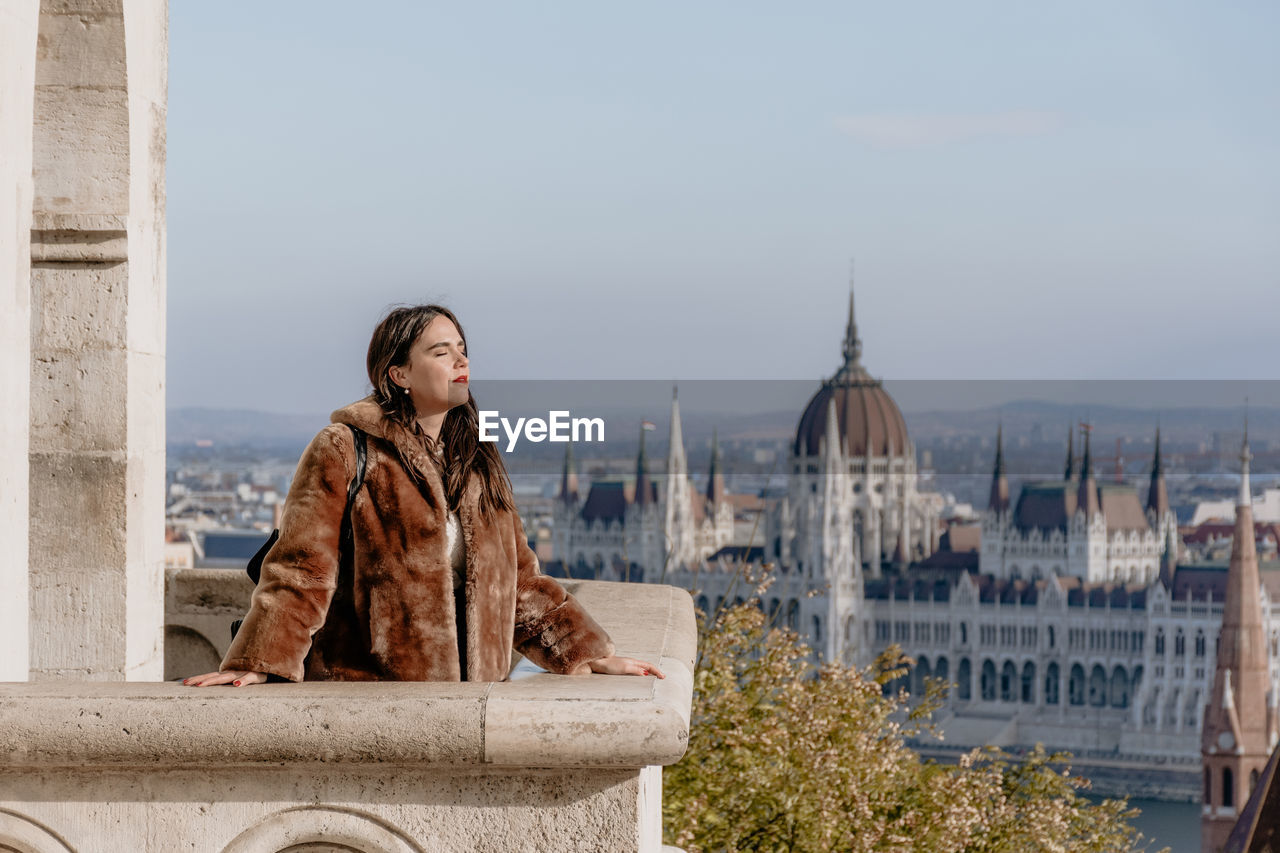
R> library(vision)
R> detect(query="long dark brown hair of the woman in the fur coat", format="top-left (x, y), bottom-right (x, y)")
top-left (366, 305), bottom-right (516, 517)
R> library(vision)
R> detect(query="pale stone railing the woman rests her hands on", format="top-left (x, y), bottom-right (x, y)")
top-left (0, 581), bottom-right (696, 853)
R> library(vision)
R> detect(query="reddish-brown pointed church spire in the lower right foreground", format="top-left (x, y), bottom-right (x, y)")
top-left (1201, 423), bottom-right (1276, 853)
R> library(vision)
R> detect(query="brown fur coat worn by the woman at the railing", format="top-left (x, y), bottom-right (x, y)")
top-left (220, 398), bottom-right (613, 681)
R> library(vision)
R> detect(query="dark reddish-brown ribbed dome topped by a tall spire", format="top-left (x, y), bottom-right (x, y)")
top-left (795, 286), bottom-right (910, 456)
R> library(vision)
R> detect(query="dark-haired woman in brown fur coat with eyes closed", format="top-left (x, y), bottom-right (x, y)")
top-left (183, 305), bottom-right (666, 686)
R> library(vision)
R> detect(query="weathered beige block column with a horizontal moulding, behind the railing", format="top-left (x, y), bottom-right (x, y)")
top-left (29, 0), bottom-right (168, 680)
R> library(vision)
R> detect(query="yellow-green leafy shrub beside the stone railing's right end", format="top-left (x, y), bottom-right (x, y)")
top-left (663, 602), bottom-right (1167, 853)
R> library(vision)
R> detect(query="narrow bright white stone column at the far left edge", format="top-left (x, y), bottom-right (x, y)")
top-left (0, 0), bottom-right (40, 681)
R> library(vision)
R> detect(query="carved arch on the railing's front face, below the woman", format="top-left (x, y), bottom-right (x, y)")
top-left (223, 806), bottom-right (425, 853)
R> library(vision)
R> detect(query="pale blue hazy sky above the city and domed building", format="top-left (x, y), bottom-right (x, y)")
top-left (168, 0), bottom-right (1280, 412)
